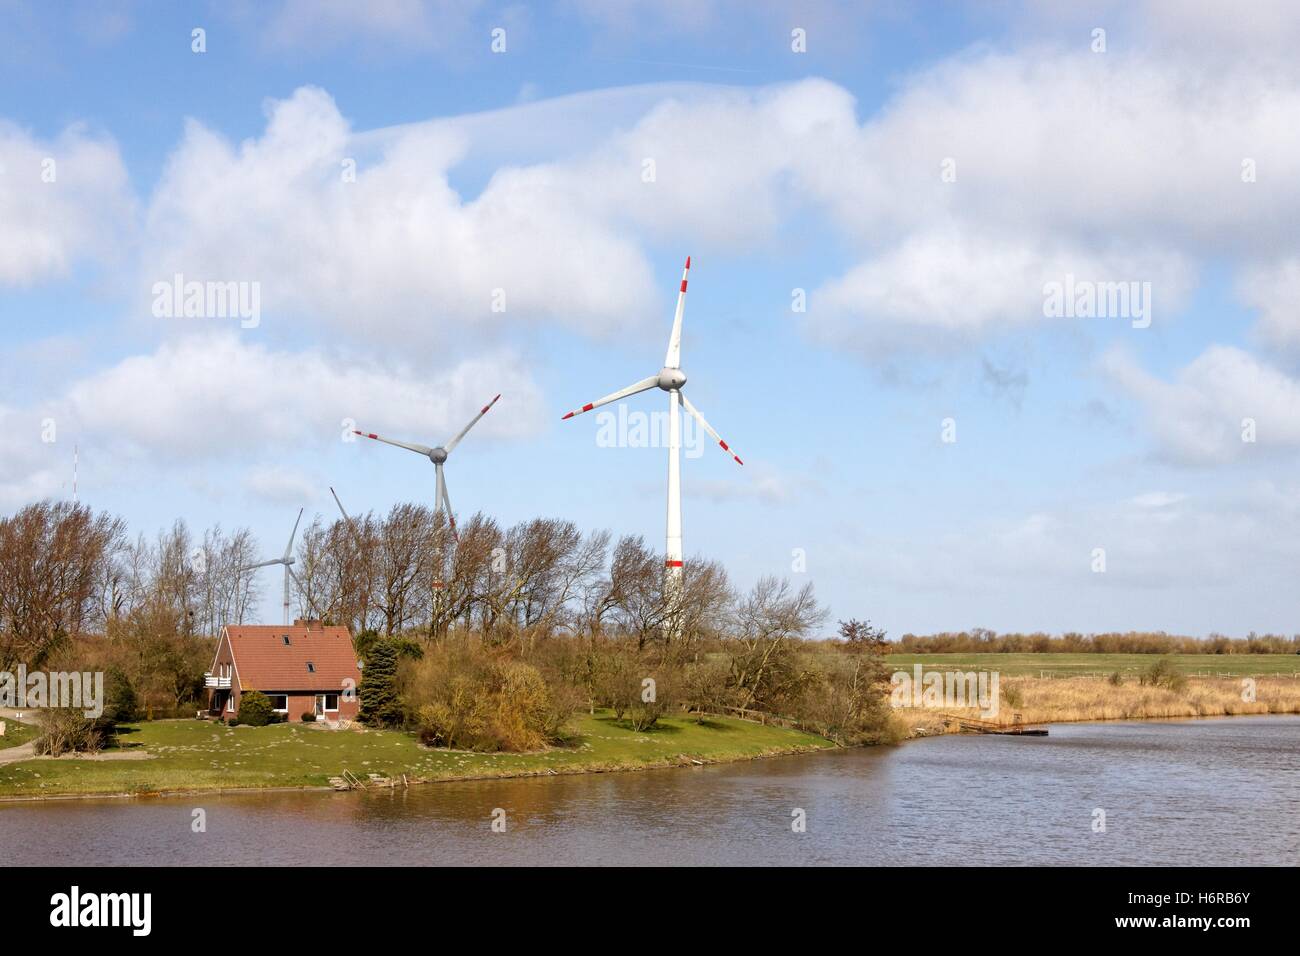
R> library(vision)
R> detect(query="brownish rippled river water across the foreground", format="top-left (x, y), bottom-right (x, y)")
top-left (0, 715), bottom-right (1300, 866)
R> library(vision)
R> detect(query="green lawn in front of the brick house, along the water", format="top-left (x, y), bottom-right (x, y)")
top-left (0, 711), bottom-right (832, 797)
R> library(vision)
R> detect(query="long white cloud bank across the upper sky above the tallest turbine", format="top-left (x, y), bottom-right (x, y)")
top-left (126, 60), bottom-right (1300, 351)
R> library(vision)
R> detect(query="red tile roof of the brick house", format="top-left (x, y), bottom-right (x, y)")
top-left (225, 624), bottom-right (361, 691)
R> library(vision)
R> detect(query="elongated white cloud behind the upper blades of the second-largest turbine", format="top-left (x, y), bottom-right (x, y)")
top-left (40, 334), bottom-right (541, 462)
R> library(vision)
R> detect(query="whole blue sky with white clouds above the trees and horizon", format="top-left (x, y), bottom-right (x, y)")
top-left (0, 0), bottom-right (1300, 636)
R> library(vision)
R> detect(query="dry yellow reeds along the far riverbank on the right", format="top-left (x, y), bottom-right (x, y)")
top-left (898, 675), bottom-right (1300, 735)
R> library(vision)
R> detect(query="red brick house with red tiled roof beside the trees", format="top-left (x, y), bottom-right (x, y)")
top-left (204, 619), bottom-right (361, 721)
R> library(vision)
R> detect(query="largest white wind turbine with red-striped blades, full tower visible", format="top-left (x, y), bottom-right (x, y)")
top-left (564, 256), bottom-right (744, 630)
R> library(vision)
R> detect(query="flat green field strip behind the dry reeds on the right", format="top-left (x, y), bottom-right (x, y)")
top-left (888, 654), bottom-right (1300, 678)
